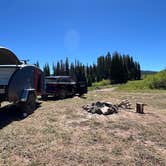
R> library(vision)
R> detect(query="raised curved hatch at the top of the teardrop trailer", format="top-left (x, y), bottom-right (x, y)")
top-left (0, 47), bottom-right (21, 65)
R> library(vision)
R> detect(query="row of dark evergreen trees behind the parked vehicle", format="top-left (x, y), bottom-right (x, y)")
top-left (37, 52), bottom-right (141, 86)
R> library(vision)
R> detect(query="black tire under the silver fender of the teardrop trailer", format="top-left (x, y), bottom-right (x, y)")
top-left (20, 93), bottom-right (36, 115)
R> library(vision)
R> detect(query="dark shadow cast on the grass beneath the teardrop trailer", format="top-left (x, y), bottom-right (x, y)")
top-left (0, 103), bottom-right (41, 129)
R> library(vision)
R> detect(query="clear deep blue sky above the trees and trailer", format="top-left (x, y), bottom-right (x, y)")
top-left (0, 0), bottom-right (166, 71)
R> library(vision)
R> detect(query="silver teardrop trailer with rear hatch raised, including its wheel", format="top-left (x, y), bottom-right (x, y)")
top-left (0, 47), bottom-right (44, 114)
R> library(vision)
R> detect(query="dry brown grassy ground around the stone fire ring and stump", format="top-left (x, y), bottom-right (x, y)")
top-left (0, 89), bottom-right (166, 166)
